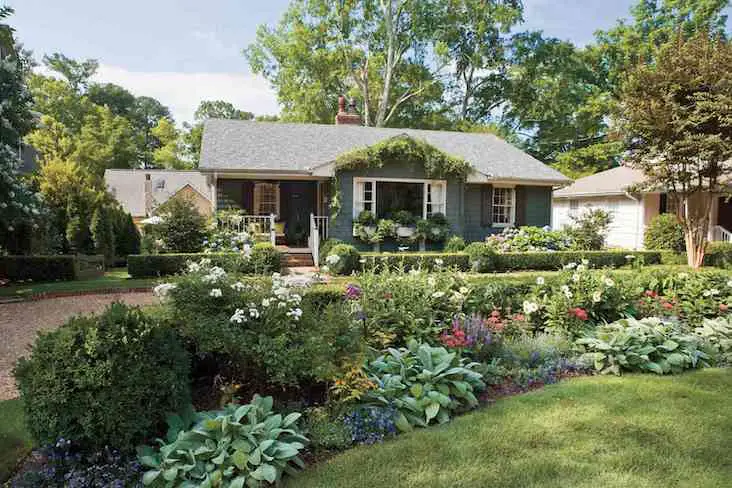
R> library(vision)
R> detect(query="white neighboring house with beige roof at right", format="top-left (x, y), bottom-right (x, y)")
top-left (552, 166), bottom-right (732, 249)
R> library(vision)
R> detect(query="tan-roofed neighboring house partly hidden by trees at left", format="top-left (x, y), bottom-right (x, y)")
top-left (104, 169), bottom-right (213, 225)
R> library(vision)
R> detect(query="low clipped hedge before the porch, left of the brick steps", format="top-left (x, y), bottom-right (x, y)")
top-left (127, 242), bottom-right (281, 278)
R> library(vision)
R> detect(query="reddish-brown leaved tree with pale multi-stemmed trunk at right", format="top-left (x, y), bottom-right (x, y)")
top-left (621, 32), bottom-right (732, 268)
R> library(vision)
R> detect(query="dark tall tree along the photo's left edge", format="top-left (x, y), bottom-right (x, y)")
top-left (0, 7), bottom-right (43, 252)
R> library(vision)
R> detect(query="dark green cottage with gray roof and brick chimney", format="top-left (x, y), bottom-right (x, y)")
top-left (199, 97), bottom-right (570, 260)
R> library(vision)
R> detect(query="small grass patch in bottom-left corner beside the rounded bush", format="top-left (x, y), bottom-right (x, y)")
top-left (0, 399), bottom-right (32, 483)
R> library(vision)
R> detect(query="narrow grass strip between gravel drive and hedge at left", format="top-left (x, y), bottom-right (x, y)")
top-left (0, 268), bottom-right (158, 296)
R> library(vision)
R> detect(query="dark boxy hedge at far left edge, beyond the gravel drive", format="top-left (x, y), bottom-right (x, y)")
top-left (0, 255), bottom-right (104, 281)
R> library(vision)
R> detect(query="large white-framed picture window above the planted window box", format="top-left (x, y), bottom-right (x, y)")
top-left (353, 178), bottom-right (447, 219)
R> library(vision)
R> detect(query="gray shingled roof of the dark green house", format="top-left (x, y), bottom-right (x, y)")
top-left (199, 119), bottom-right (570, 184)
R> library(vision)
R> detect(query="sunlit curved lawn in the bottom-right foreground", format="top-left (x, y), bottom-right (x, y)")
top-left (286, 369), bottom-right (732, 488)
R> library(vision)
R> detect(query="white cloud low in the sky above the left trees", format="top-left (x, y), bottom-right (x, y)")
top-left (89, 64), bottom-right (279, 124)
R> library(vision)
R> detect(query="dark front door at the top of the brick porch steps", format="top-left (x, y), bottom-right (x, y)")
top-left (280, 181), bottom-right (316, 247)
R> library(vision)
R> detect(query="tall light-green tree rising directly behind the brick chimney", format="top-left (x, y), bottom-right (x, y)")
top-left (245, 0), bottom-right (444, 126)
